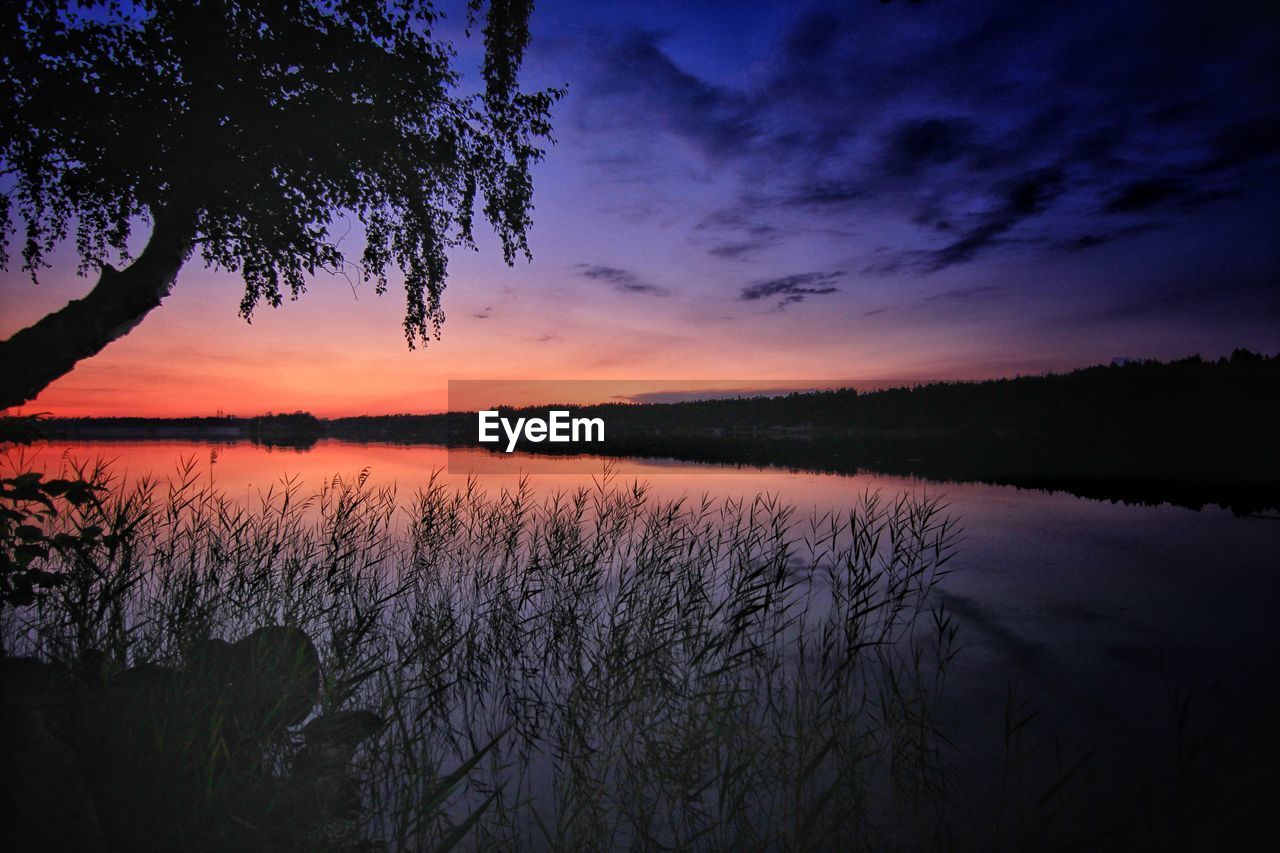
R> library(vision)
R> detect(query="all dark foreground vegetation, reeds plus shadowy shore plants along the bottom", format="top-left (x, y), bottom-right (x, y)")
top-left (0, 448), bottom-right (1259, 850)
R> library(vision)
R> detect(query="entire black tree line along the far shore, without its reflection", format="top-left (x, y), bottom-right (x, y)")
top-left (35, 350), bottom-right (1280, 442)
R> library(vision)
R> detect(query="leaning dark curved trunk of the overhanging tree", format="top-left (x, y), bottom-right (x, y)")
top-left (0, 205), bottom-right (196, 409)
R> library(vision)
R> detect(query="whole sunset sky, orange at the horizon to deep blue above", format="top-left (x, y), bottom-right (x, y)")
top-left (0, 0), bottom-right (1280, 416)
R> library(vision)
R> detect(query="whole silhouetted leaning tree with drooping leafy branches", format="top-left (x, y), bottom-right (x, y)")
top-left (0, 0), bottom-right (563, 409)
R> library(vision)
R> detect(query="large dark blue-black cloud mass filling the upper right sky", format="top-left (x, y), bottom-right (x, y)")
top-left (573, 0), bottom-right (1280, 274)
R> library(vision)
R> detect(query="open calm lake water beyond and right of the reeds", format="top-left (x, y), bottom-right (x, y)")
top-left (10, 441), bottom-right (1280, 804)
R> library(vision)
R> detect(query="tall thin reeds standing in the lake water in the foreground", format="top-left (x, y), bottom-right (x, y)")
top-left (0, 462), bottom-right (957, 850)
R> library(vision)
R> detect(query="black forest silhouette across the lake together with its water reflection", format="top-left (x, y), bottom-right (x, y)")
top-left (45, 350), bottom-right (1280, 514)
